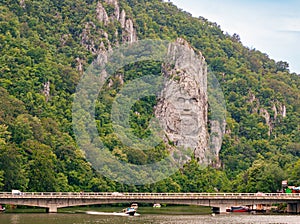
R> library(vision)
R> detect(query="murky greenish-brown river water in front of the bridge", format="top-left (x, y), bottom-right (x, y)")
top-left (0, 207), bottom-right (300, 224)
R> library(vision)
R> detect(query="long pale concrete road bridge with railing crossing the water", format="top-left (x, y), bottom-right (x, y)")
top-left (0, 192), bottom-right (300, 213)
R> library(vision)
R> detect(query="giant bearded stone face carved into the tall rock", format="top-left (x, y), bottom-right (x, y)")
top-left (156, 74), bottom-right (206, 164)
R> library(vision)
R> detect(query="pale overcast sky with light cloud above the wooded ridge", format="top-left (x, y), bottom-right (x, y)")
top-left (171, 0), bottom-right (300, 74)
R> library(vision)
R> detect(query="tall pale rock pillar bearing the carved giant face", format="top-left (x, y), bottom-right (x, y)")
top-left (155, 38), bottom-right (209, 164)
